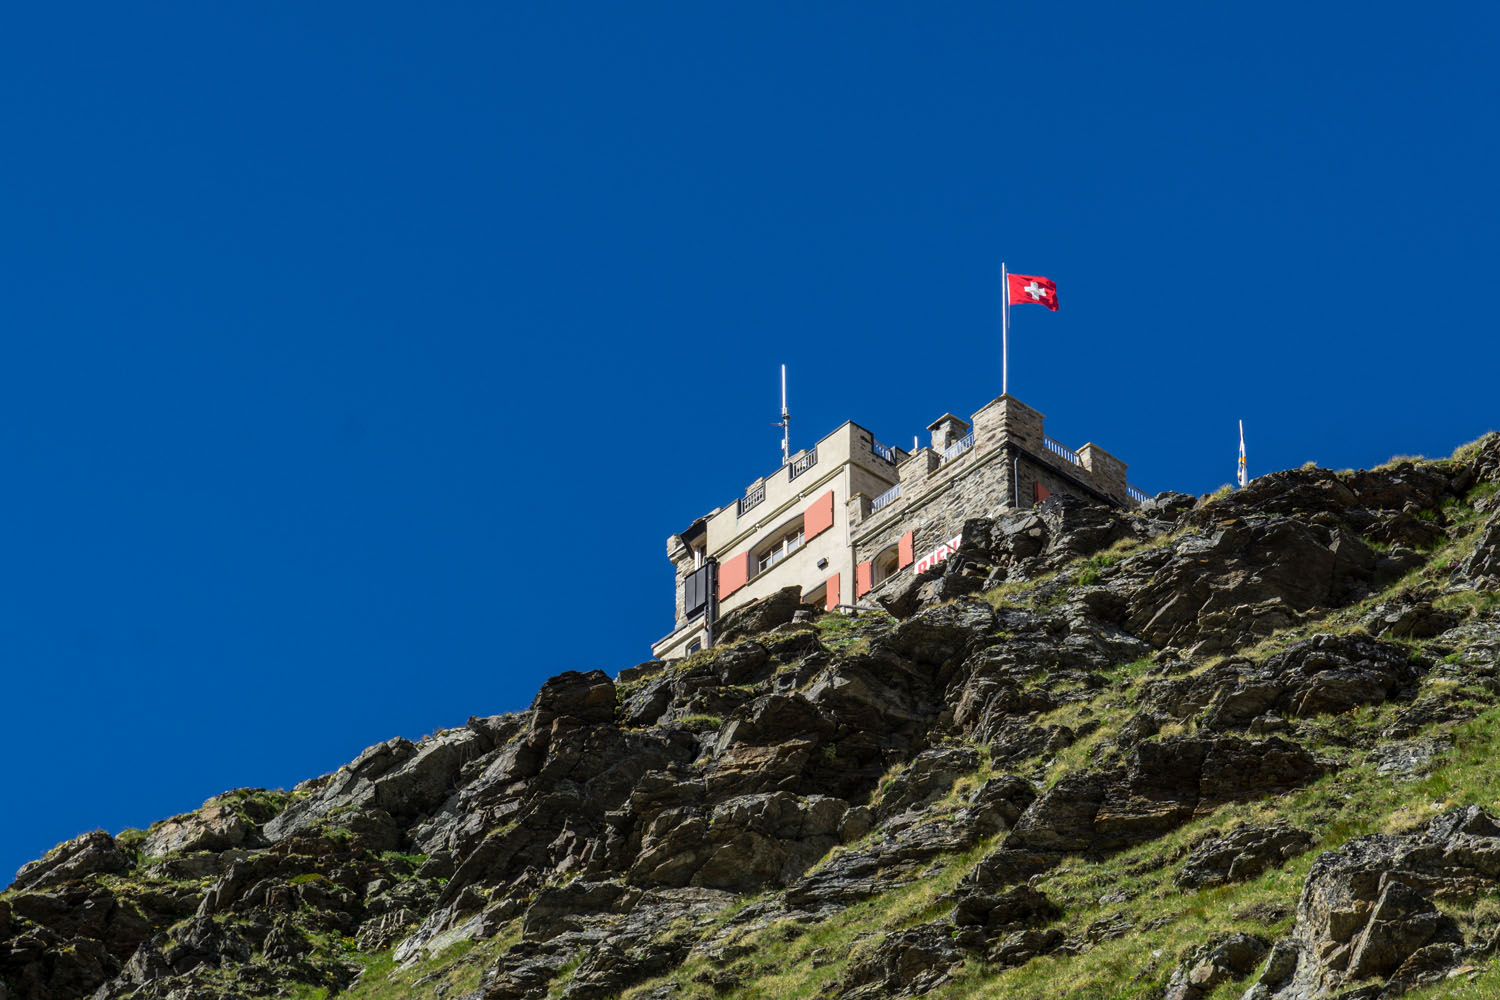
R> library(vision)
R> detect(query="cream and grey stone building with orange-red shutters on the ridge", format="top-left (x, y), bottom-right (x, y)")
top-left (651, 396), bottom-right (1146, 658)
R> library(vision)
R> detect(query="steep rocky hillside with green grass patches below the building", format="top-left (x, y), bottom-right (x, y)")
top-left (0, 435), bottom-right (1500, 1000)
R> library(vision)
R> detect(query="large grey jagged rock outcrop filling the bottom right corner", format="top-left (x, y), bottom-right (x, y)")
top-left (1247, 805), bottom-right (1500, 1000)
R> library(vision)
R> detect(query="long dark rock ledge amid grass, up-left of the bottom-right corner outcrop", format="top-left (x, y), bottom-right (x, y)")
top-left (1005, 736), bottom-right (1323, 853)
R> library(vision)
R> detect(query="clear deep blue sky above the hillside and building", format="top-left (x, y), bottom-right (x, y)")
top-left (0, 3), bottom-right (1500, 883)
